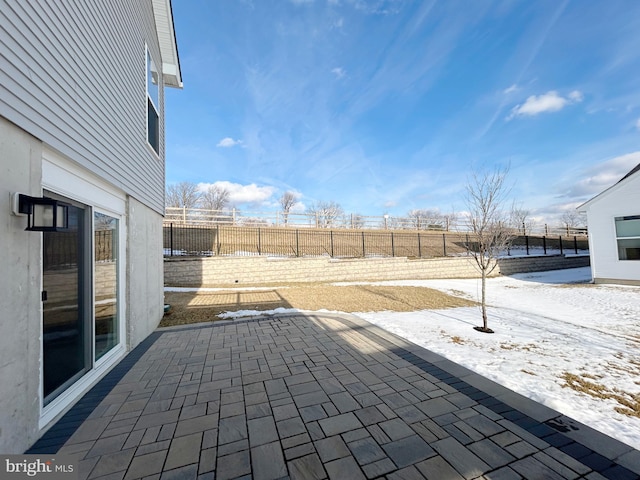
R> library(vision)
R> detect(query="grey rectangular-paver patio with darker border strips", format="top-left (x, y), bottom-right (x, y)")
top-left (27, 313), bottom-right (640, 480)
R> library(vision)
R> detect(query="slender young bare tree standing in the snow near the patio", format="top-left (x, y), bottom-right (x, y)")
top-left (466, 168), bottom-right (512, 333)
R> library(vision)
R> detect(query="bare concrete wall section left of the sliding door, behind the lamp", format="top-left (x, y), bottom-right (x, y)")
top-left (0, 117), bottom-right (42, 453)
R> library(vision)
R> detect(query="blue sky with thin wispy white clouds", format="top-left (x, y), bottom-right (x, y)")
top-left (165, 0), bottom-right (640, 224)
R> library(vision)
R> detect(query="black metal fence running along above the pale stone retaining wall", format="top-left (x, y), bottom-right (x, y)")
top-left (163, 223), bottom-right (589, 258)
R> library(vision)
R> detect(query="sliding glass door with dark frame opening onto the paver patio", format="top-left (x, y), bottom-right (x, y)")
top-left (42, 192), bottom-right (121, 405)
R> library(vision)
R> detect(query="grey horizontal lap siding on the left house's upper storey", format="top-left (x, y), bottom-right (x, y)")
top-left (0, 0), bottom-right (164, 214)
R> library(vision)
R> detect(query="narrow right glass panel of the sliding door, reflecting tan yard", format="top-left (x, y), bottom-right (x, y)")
top-left (93, 212), bottom-right (119, 360)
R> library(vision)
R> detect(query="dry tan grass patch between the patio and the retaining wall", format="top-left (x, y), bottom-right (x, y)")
top-left (160, 284), bottom-right (475, 327)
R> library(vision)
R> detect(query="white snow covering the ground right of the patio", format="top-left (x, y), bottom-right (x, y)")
top-left (350, 267), bottom-right (640, 449)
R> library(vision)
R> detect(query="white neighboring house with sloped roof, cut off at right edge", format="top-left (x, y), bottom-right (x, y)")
top-left (578, 164), bottom-right (640, 285)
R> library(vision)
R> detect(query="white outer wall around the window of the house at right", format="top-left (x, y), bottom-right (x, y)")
top-left (585, 174), bottom-right (640, 285)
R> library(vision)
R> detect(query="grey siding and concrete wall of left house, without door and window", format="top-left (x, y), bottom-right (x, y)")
top-left (0, 0), bottom-right (174, 454)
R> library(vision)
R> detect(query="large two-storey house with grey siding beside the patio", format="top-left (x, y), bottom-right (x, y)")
top-left (0, 0), bottom-right (182, 454)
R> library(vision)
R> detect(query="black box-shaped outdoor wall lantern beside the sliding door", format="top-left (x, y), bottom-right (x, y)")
top-left (12, 193), bottom-right (69, 232)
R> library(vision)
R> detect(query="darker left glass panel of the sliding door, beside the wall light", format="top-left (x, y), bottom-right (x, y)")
top-left (42, 199), bottom-right (91, 404)
